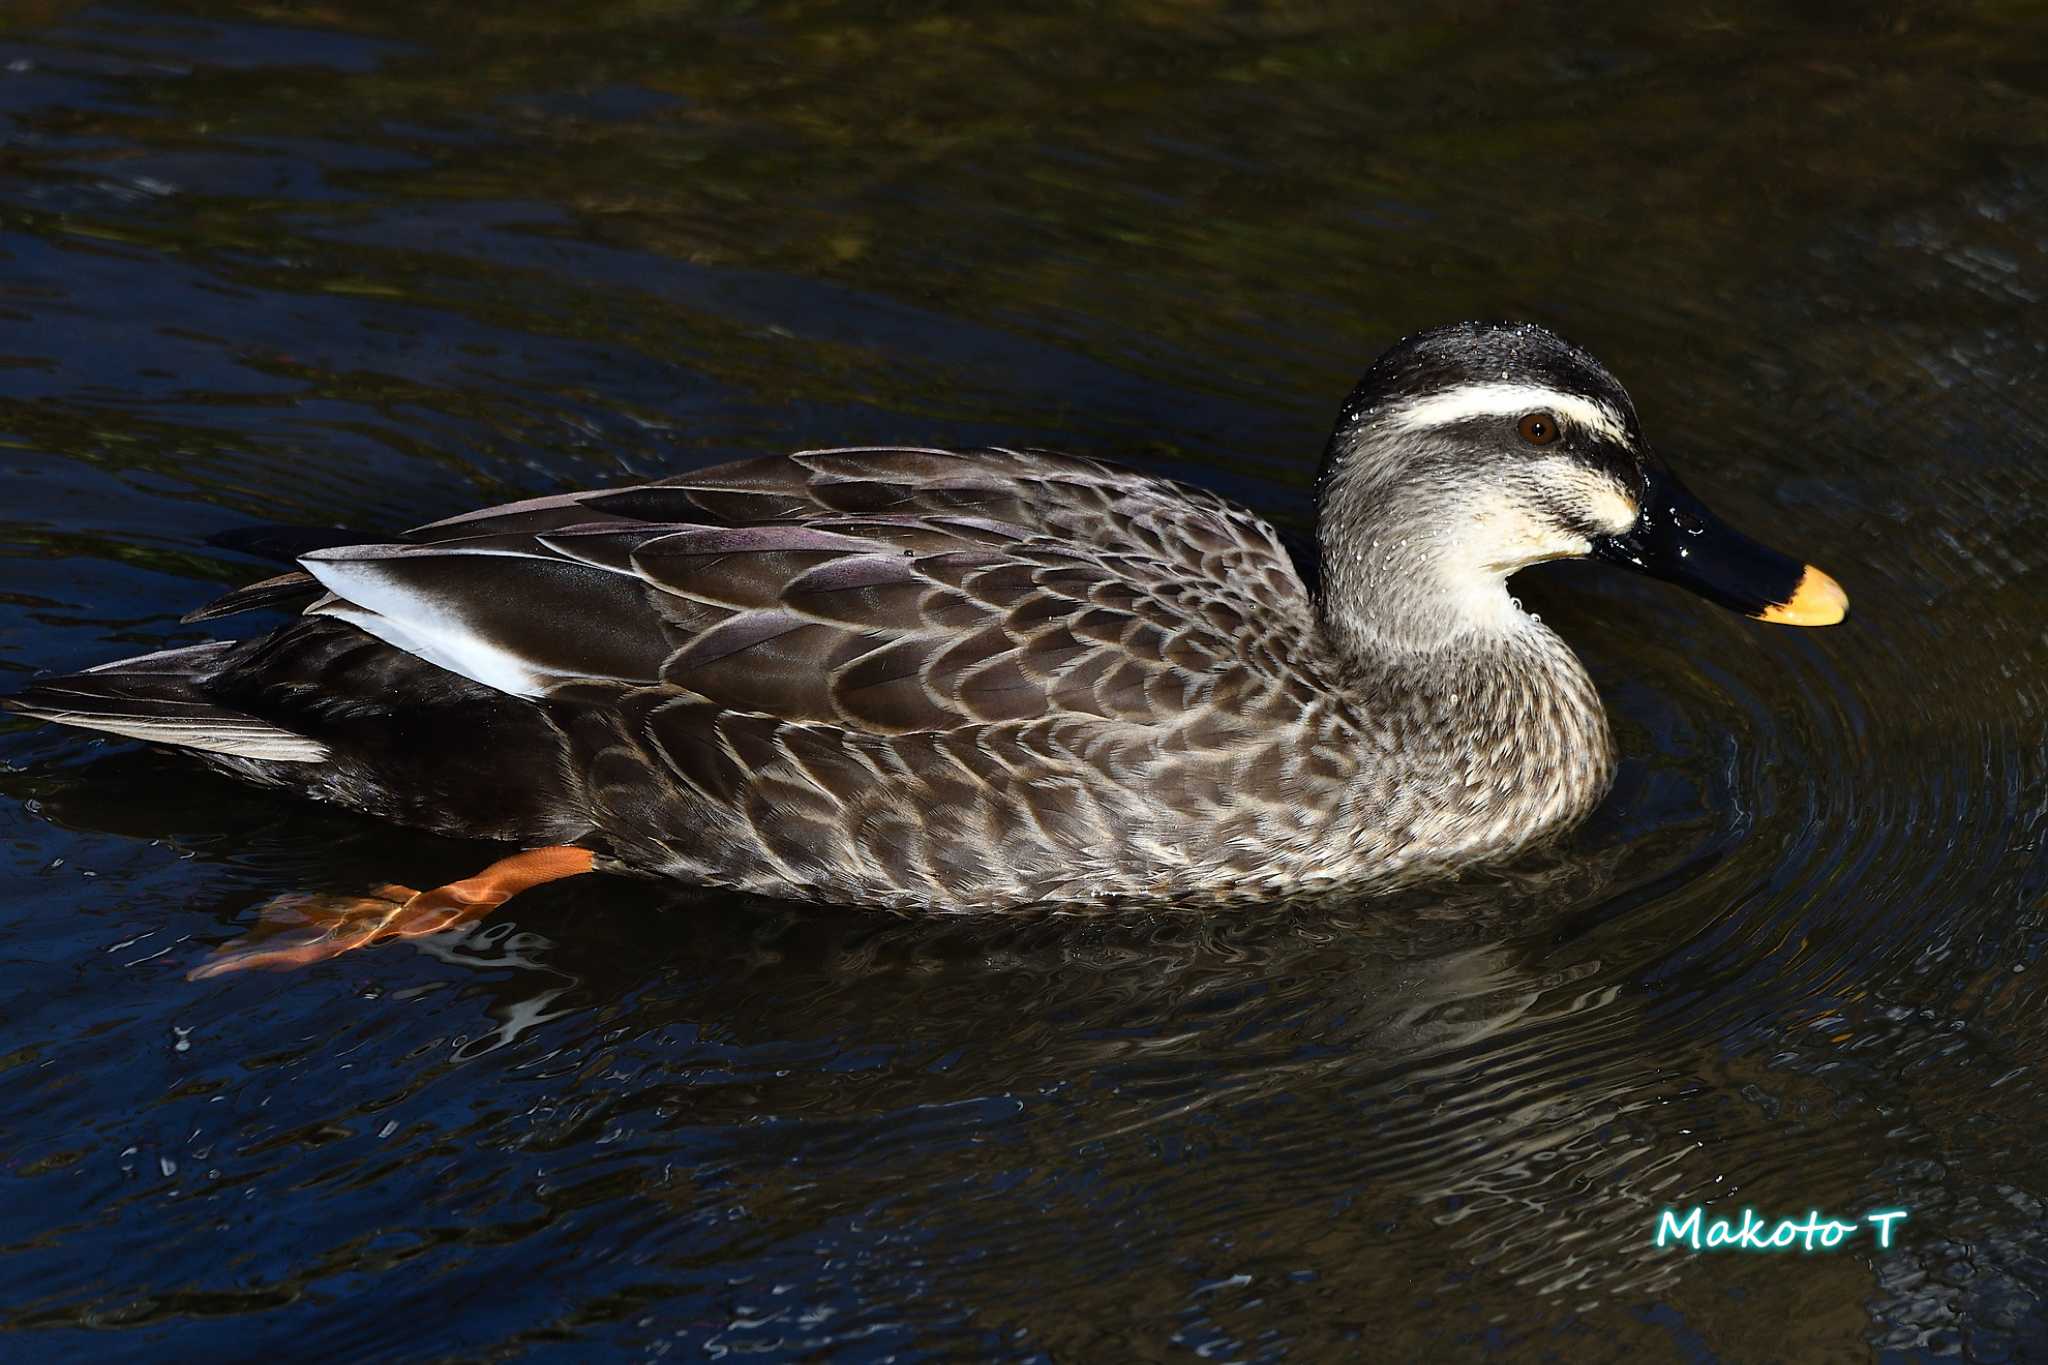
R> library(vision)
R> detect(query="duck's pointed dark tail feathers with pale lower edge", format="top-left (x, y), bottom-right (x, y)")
top-left (0, 641), bottom-right (328, 763)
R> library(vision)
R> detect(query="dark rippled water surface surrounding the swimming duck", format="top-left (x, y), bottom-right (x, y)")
top-left (0, 0), bottom-right (2048, 1361)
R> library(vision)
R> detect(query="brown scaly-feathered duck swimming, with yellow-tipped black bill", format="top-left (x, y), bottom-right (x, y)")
top-left (6, 321), bottom-right (1847, 976)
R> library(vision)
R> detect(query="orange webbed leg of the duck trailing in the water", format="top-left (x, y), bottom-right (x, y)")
top-left (190, 843), bottom-right (592, 980)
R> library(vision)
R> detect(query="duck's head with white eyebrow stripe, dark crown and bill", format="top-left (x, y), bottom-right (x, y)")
top-left (1319, 323), bottom-right (1849, 647)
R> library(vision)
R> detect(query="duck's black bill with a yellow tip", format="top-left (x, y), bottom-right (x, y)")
top-left (1593, 473), bottom-right (1849, 626)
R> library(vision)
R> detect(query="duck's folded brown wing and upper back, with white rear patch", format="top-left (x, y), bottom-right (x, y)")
top-left (260, 450), bottom-right (1313, 735)
